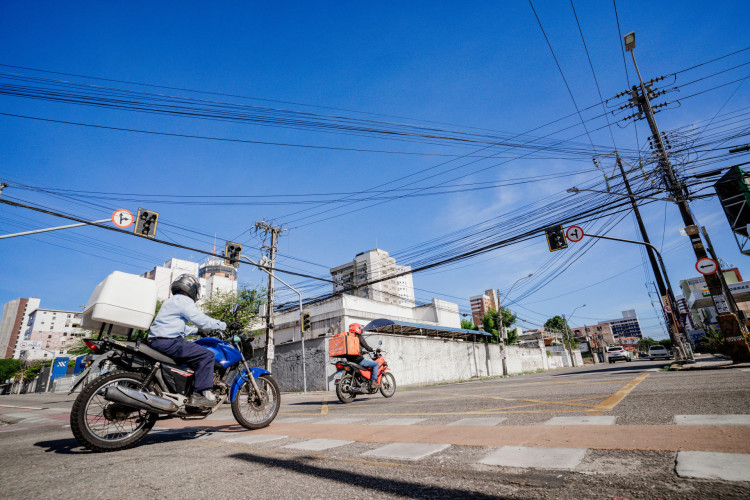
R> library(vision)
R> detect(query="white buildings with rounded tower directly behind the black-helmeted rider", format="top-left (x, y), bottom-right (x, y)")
top-left (141, 256), bottom-right (237, 302)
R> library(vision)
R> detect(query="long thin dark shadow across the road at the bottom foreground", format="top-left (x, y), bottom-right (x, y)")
top-left (230, 453), bottom-right (503, 499)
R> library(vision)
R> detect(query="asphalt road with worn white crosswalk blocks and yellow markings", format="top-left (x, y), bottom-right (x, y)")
top-left (0, 361), bottom-right (750, 498)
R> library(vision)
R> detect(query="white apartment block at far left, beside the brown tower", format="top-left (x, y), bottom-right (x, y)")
top-left (13, 308), bottom-right (89, 360)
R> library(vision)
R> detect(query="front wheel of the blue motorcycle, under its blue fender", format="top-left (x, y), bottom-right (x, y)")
top-left (232, 374), bottom-right (281, 430)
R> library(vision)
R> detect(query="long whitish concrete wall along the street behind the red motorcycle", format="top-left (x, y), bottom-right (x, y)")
top-left (252, 334), bottom-right (568, 392)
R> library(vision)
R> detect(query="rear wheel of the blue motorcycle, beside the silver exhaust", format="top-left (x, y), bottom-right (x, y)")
top-left (70, 371), bottom-right (157, 451)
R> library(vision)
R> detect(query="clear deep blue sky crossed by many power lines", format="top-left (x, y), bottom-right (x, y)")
top-left (0, 1), bottom-right (750, 337)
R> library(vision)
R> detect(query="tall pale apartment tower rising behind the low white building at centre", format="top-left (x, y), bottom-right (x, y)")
top-left (331, 248), bottom-right (415, 307)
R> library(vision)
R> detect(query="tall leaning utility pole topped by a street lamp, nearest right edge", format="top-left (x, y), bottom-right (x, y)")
top-left (624, 32), bottom-right (750, 357)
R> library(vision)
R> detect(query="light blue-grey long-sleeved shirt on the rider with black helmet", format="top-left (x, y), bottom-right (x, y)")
top-left (148, 295), bottom-right (227, 339)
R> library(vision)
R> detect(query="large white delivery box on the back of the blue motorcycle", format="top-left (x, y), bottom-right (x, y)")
top-left (81, 271), bottom-right (156, 334)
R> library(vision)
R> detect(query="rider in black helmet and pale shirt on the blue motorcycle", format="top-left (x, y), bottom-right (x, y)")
top-left (148, 274), bottom-right (239, 407)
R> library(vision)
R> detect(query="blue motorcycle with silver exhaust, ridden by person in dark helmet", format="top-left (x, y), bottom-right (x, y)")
top-left (70, 327), bottom-right (281, 451)
